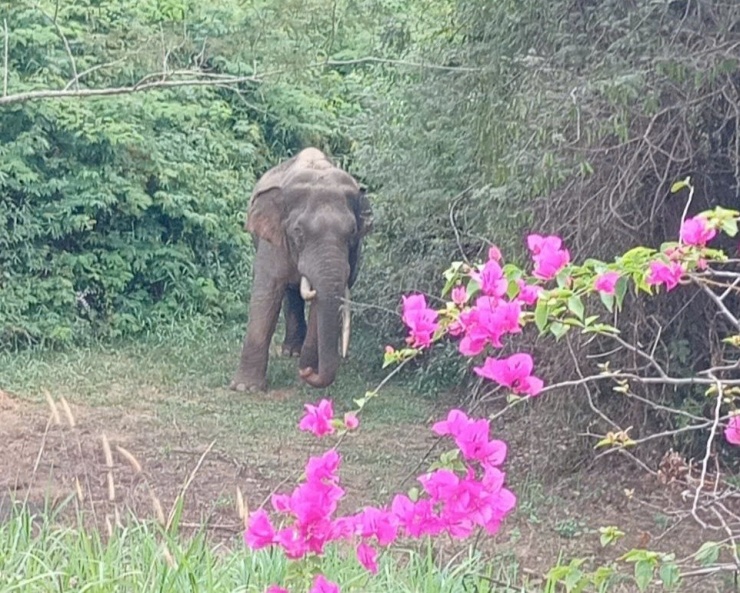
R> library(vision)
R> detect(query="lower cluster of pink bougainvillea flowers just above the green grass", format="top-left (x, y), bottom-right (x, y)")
top-left (244, 404), bottom-right (516, 593)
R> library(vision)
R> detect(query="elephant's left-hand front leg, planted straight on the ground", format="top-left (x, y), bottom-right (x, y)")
top-left (229, 272), bottom-right (285, 391)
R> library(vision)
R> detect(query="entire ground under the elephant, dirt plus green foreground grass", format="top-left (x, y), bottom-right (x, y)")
top-left (0, 322), bottom-right (723, 593)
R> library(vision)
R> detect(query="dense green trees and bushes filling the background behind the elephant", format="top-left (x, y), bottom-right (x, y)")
top-left (0, 0), bottom-right (740, 438)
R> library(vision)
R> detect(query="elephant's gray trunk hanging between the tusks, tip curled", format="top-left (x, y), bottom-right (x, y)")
top-left (300, 266), bottom-right (348, 388)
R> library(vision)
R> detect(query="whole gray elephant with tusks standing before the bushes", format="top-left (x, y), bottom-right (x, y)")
top-left (230, 148), bottom-right (372, 391)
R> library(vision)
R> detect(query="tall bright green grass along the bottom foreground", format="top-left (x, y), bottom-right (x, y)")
top-left (0, 506), bottom-right (529, 593)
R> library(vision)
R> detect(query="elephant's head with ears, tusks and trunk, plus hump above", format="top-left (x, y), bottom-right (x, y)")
top-left (246, 148), bottom-right (373, 387)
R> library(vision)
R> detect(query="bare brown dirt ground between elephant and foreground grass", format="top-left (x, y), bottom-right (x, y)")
top-left (0, 376), bottom-right (726, 591)
